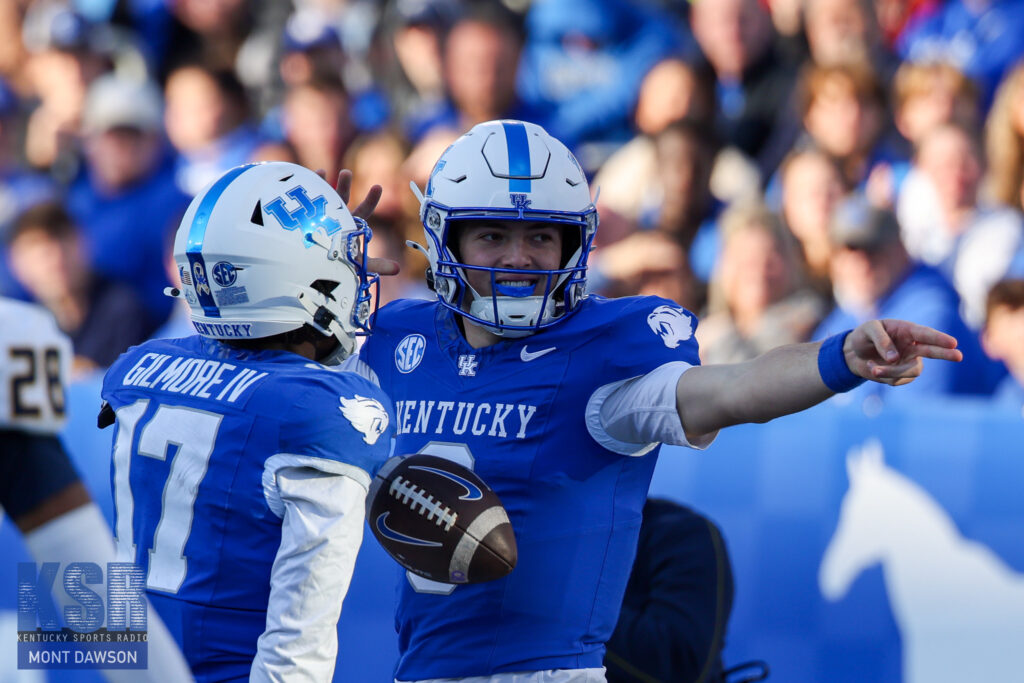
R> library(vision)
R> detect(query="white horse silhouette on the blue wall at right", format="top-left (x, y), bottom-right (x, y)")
top-left (818, 440), bottom-right (1024, 683)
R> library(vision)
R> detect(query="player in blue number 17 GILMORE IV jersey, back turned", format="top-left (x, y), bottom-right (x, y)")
top-left (102, 163), bottom-right (394, 681)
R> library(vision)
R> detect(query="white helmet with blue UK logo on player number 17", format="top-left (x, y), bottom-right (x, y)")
top-left (169, 162), bottom-right (377, 365)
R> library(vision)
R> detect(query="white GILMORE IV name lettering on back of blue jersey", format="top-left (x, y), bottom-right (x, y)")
top-left (121, 353), bottom-right (267, 403)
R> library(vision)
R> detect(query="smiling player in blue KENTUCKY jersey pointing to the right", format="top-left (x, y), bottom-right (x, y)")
top-left (338, 121), bottom-right (959, 683)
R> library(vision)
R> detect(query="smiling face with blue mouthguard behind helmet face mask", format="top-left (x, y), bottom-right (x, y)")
top-left (453, 220), bottom-right (564, 297)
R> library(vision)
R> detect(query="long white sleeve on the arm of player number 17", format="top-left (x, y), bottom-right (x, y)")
top-left (250, 456), bottom-right (369, 682)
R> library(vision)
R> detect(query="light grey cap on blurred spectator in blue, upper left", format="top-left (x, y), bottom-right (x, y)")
top-left (82, 74), bottom-right (164, 134)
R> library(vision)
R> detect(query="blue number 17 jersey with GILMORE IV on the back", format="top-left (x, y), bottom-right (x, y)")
top-left (102, 337), bottom-right (394, 680)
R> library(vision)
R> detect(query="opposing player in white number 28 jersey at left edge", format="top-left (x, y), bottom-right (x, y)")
top-left (0, 297), bottom-right (190, 681)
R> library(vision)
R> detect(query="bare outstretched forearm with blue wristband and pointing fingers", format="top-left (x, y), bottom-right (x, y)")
top-left (676, 319), bottom-right (963, 441)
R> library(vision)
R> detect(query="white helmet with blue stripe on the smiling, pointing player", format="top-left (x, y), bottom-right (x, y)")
top-left (409, 121), bottom-right (598, 338)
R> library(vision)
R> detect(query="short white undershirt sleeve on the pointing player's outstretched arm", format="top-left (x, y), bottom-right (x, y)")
top-left (587, 360), bottom-right (717, 456)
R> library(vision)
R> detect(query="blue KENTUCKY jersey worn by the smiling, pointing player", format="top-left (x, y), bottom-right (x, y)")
top-left (360, 297), bottom-right (698, 680)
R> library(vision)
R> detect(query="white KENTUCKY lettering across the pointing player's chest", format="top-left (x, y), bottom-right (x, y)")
top-left (394, 400), bottom-right (537, 438)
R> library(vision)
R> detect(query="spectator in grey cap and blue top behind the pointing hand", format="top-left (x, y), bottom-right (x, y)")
top-left (813, 197), bottom-right (1000, 410)
